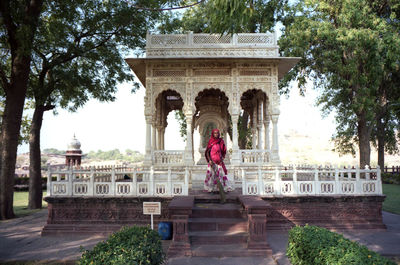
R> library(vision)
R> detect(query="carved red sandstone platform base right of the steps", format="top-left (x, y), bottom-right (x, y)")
top-left (263, 195), bottom-right (386, 230)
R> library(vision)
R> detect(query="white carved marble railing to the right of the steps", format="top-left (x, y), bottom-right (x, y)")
top-left (241, 166), bottom-right (382, 196)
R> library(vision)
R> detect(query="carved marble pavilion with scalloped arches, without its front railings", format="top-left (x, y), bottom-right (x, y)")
top-left (126, 32), bottom-right (298, 177)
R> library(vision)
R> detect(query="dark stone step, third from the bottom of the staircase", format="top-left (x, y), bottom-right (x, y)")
top-left (189, 218), bottom-right (247, 232)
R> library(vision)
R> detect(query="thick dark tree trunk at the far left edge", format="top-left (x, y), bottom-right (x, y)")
top-left (0, 0), bottom-right (43, 219)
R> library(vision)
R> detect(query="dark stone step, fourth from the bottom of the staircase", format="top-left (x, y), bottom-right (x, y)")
top-left (190, 203), bottom-right (242, 218)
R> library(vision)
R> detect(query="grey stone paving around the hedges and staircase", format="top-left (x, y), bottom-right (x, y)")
top-left (0, 210), bottom-right (400, 265)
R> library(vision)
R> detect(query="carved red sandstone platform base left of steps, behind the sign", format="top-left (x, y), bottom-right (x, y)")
top-left (42, 197), bottom-right (172, 235)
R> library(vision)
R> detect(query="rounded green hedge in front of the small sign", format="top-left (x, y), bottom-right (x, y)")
top-left (78, 226), bottom-right (165, 265)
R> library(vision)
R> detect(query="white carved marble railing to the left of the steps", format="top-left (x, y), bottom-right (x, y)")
top-left (47, 166), bottom-right (189, 197)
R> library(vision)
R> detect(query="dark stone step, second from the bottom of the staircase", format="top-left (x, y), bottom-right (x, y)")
top-left (189, 231), bottom-right (248, 245)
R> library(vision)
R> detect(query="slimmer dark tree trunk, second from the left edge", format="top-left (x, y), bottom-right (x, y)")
top-left (28, 106), bottom-right (44, 209)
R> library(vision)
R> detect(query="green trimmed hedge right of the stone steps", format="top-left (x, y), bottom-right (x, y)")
top-left (286, 225), bottom-right (396, 265)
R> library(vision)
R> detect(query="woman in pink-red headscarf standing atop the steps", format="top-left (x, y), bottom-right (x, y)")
top-left (204, 129), bottom-right (232, 192)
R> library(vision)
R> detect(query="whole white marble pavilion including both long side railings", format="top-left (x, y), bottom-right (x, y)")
top-left (47, 32), bottom-right (382, 197)
